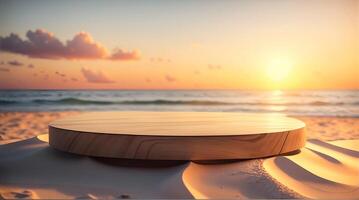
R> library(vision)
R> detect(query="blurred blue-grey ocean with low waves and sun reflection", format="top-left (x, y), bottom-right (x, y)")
top-left (0, 90), bottom-right (359, 117)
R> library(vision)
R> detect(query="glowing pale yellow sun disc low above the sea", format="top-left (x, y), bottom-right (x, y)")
top-left (266, 59), bottom-right (292, 82)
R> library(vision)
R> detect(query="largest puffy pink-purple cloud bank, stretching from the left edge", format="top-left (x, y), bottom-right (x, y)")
top-left (0, 29), bottom-right (140, 60)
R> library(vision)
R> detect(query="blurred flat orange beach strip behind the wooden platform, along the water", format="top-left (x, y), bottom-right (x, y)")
top-left (0, 111), bottom-right (359, 144)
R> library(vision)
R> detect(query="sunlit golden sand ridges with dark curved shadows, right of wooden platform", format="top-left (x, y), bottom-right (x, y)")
top-left (263, 140), bottom-right (359, 199)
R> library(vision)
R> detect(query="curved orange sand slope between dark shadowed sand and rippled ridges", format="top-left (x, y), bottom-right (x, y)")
top-left (183, 159), bottom-right (300, 199)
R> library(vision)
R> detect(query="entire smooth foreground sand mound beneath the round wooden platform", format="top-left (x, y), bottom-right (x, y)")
top-left (0, 135), bottom-right (359, 199)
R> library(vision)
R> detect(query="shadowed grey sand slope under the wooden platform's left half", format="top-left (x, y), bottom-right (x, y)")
top-left (0, 138), bottom-right (192, 199)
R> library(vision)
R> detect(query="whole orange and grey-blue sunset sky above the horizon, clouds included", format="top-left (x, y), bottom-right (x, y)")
top-left (0, 0), bottom-right (359, 90)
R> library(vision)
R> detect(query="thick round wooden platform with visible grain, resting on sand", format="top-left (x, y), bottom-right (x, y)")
top-left (49, 112), bottom-right (305, 160)
